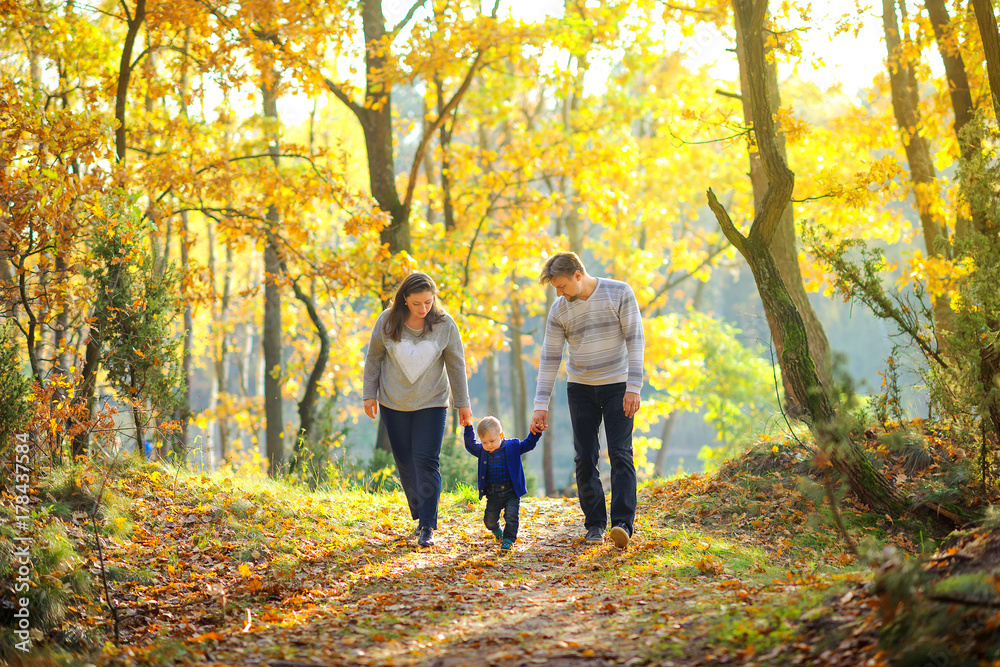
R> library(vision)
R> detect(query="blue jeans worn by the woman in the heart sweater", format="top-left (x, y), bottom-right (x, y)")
top-left (379, 405), bottom-right (448, 530)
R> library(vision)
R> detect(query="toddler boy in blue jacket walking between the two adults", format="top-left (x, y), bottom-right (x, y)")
top-left (465, 416), bottom-right (542, 551)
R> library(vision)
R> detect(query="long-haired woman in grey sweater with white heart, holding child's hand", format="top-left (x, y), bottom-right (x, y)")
top-left (362, 273), bottom-right (472, 547)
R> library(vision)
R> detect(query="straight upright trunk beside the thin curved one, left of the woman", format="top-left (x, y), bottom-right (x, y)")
top-left (261, 68), bottom-right (285, 477)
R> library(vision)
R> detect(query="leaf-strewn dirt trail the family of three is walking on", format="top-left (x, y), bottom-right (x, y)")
top-left (170, 498), bottom-right (696, 667)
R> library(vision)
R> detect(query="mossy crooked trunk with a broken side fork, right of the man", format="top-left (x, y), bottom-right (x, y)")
top-left (708, 0), bottom-right (905, 516)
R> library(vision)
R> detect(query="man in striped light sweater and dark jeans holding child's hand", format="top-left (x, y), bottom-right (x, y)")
top-left (531, 252), bottom-right (645, 549)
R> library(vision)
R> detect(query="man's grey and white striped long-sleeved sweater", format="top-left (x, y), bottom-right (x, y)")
top-left (535, 278), bottom-right (646, 410)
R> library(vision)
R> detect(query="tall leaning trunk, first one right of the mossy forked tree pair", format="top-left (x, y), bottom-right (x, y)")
top-left (882, 0), bottom-right (952, 347)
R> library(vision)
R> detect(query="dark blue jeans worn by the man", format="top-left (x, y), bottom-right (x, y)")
top-left (566, 382), bottom-right (636, 535)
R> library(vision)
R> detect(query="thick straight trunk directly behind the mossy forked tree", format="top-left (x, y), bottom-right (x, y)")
top-left (736, 5), bottom-right (833, 402)
